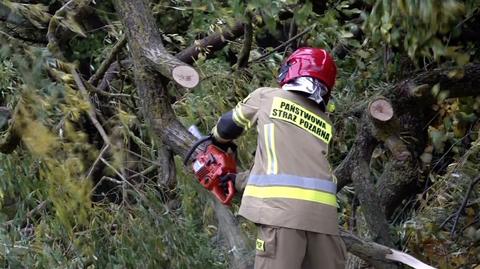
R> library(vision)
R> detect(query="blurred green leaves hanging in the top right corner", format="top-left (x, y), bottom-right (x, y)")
top-left (366, 0), bottom-right (469, 65)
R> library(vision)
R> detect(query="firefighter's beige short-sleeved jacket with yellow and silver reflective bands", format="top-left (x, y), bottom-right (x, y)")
top-left (212, 88), bottom-right (338, 235)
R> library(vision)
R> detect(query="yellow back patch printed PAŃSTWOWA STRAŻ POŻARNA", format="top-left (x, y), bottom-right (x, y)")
top-left (270, 97), bottom-right (332, 144)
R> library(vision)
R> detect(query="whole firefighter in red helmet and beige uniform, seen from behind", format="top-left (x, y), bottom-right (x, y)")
top-left (212, 48), bottom-right (346, 269)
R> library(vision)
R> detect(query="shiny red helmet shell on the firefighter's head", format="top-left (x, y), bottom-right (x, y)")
top-left (278, 48), bottom-right (337, 91)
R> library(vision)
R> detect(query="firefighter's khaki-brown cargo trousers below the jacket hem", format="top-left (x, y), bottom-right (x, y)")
top-left (254, 225), bottom-right (347, 269)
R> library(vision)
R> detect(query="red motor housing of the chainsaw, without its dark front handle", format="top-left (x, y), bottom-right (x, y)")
top-left (193, 144), bottom-right (237, 205)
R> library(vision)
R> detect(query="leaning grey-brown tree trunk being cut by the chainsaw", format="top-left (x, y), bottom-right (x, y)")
top-left (114, 0), bottom-right (247, 268)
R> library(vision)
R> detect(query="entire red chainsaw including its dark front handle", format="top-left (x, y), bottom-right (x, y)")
top-left (183, 131), bottom-right (237, 205)
